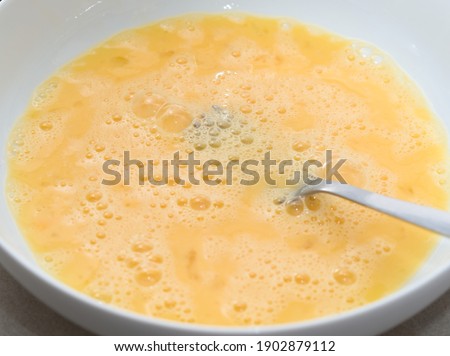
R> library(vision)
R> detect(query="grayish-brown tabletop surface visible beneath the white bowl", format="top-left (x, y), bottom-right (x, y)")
top-left (0, 267), bottom-right (450, 336)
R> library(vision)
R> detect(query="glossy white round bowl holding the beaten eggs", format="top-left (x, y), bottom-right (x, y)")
top-left (0, 0), bottom-right (450, 335)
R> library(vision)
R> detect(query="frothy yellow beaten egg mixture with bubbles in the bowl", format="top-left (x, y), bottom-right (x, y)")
top-left (7, 14), bottom-right (449, 325)
